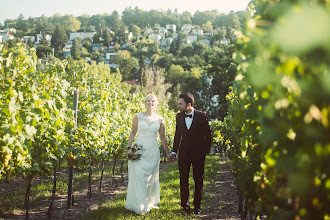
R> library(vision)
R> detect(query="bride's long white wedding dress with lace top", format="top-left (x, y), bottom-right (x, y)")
top-left (126, 112), bottom-right (162, 215)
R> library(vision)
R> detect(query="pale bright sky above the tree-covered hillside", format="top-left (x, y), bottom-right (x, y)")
top-left (0, 0), bottom-right (250, 24)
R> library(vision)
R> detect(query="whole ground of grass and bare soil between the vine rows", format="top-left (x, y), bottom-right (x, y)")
top-left (0, 155), bottom-right (239, 220)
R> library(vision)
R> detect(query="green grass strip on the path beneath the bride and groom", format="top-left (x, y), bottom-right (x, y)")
top-left (84, 156), bottom-right (221, 220)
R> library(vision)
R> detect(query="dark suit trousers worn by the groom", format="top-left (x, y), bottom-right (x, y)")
top-left (178, 155), bottom-right (205, 208)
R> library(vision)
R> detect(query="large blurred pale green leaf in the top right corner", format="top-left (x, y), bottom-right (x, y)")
top-left (272, 3), bottom-right (330, 53)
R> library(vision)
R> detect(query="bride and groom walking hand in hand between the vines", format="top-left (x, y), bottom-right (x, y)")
top-left (126, 93), bottom-right (211, 215)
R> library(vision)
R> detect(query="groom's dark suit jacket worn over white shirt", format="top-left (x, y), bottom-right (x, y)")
top-left (172, 110), bottom-right (211, 158)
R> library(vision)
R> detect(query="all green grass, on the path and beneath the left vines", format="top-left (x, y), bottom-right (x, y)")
top-left (0, 156), bottom-right (221, 220)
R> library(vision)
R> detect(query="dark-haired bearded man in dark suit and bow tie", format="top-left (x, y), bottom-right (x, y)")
top-left (172, 93), bottom-right (211, 215)
